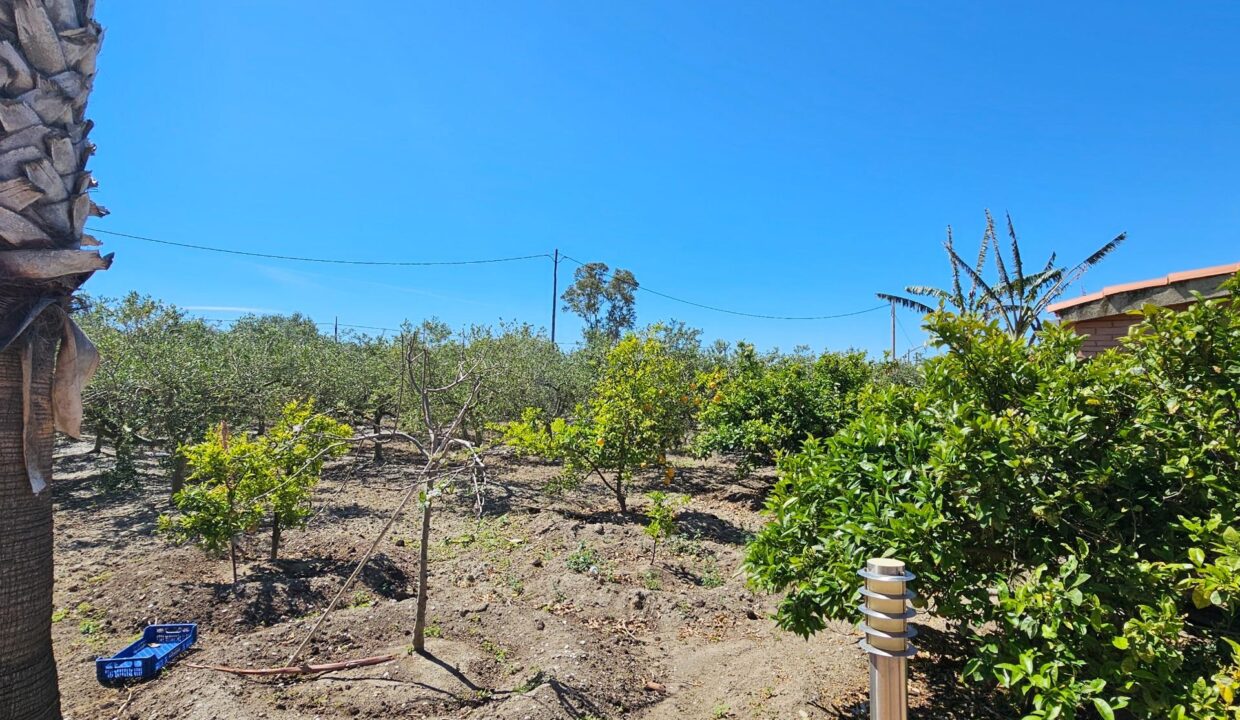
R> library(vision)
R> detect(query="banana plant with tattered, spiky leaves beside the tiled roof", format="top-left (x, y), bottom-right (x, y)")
top-left (878, 211), bottom-right (1127, 336)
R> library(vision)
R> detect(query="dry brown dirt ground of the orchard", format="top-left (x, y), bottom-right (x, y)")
top-left (53, 444), bottom-right (999, 720)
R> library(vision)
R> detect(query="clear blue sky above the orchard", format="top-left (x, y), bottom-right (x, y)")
top-left (86, 0), bottom-right (1240, 352)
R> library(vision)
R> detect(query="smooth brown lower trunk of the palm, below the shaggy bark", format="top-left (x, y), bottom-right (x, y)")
top-left (0, 320), bottom-right (61, 720)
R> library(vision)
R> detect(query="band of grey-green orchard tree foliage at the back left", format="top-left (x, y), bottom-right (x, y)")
top-left (78, 294), bottom-right (607, 490)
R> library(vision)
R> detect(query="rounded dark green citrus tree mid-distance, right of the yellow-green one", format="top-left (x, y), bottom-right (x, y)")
top-left (693, 345), bottom-right (874, 467)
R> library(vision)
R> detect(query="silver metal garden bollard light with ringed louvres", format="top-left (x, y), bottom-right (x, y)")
top-left (857, 558), bottom-right (918, 720)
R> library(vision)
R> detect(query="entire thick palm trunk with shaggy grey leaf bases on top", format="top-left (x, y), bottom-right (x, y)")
top-left (0, 0), bottom-right (110, 720)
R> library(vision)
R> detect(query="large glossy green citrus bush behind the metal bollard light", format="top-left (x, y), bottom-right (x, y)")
top-left (746, 273), bottom-right (1240, 719)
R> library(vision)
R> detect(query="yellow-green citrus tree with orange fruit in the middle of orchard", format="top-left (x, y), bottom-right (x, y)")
top-left (503, 333), bottom-right (693, 512)
